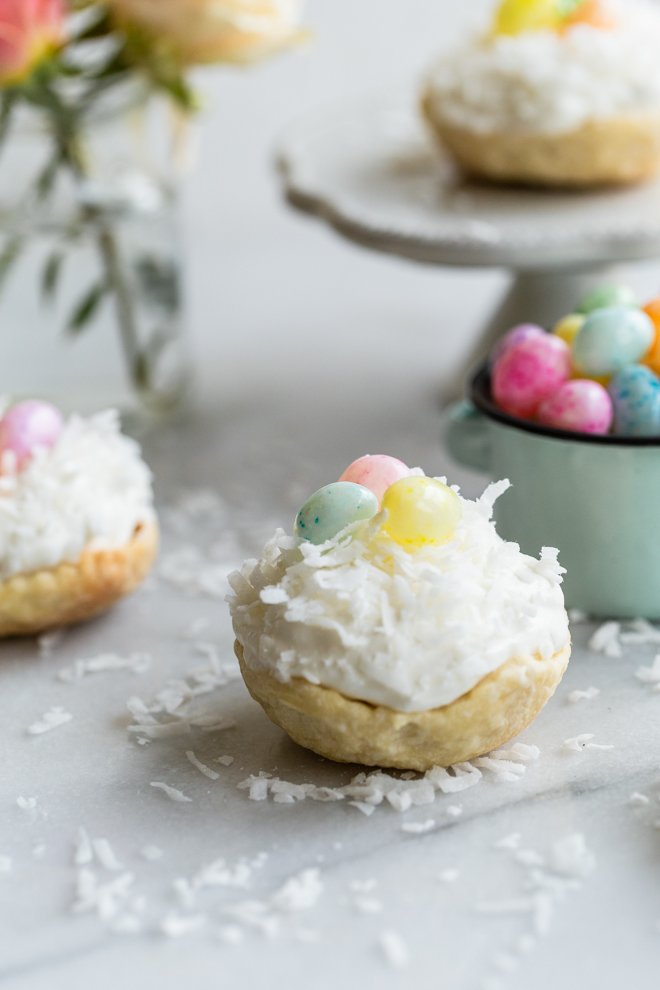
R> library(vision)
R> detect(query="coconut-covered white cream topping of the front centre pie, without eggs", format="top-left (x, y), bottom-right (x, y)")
top-left (228, 479), bottom-right (570, 711)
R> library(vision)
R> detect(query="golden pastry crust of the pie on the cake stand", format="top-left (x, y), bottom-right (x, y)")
top-left (422, 91), bottom-right (660, 188)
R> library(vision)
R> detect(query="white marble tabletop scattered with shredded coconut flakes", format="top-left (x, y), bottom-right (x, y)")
top-left (0, 404), bottom-right (660, 990)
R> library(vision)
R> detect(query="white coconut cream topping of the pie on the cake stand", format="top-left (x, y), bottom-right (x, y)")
top-left (428, 0), bottom-right (660, 133)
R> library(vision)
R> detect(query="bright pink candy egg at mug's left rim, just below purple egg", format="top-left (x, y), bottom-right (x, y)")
top-left (492, 333), bottom-right (571, 419)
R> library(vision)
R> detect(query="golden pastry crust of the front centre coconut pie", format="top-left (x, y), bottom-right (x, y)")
top-left (234, 642), bottom-right (571, 771)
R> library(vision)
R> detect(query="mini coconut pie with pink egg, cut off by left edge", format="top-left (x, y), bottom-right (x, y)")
top-left (0, 401), bottom-right (158, 636)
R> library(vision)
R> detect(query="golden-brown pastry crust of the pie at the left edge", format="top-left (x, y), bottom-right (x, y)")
top-left (0, 522), bottom-right (158, 637)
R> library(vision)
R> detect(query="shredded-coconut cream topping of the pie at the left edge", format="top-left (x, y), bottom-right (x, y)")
top-left (0, 412), bottom-right (154, 579)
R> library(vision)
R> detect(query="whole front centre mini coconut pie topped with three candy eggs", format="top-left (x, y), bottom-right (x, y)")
top-left (229, 455), bottom-right (570, 771)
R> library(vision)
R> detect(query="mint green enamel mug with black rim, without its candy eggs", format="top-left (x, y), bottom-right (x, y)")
top-left (446, 368), bottom-right (660, 619)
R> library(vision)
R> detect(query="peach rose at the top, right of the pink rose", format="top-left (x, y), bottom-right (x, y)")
top-left (108, 0), bottom-right (302, 65)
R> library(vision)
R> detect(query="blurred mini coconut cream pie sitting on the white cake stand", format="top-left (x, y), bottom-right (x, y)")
top-left (422, 0), bottom-right (660, 187)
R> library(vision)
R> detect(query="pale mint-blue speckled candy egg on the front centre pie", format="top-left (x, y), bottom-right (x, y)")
top-left (294, 481), bottom-right (378, 543)
